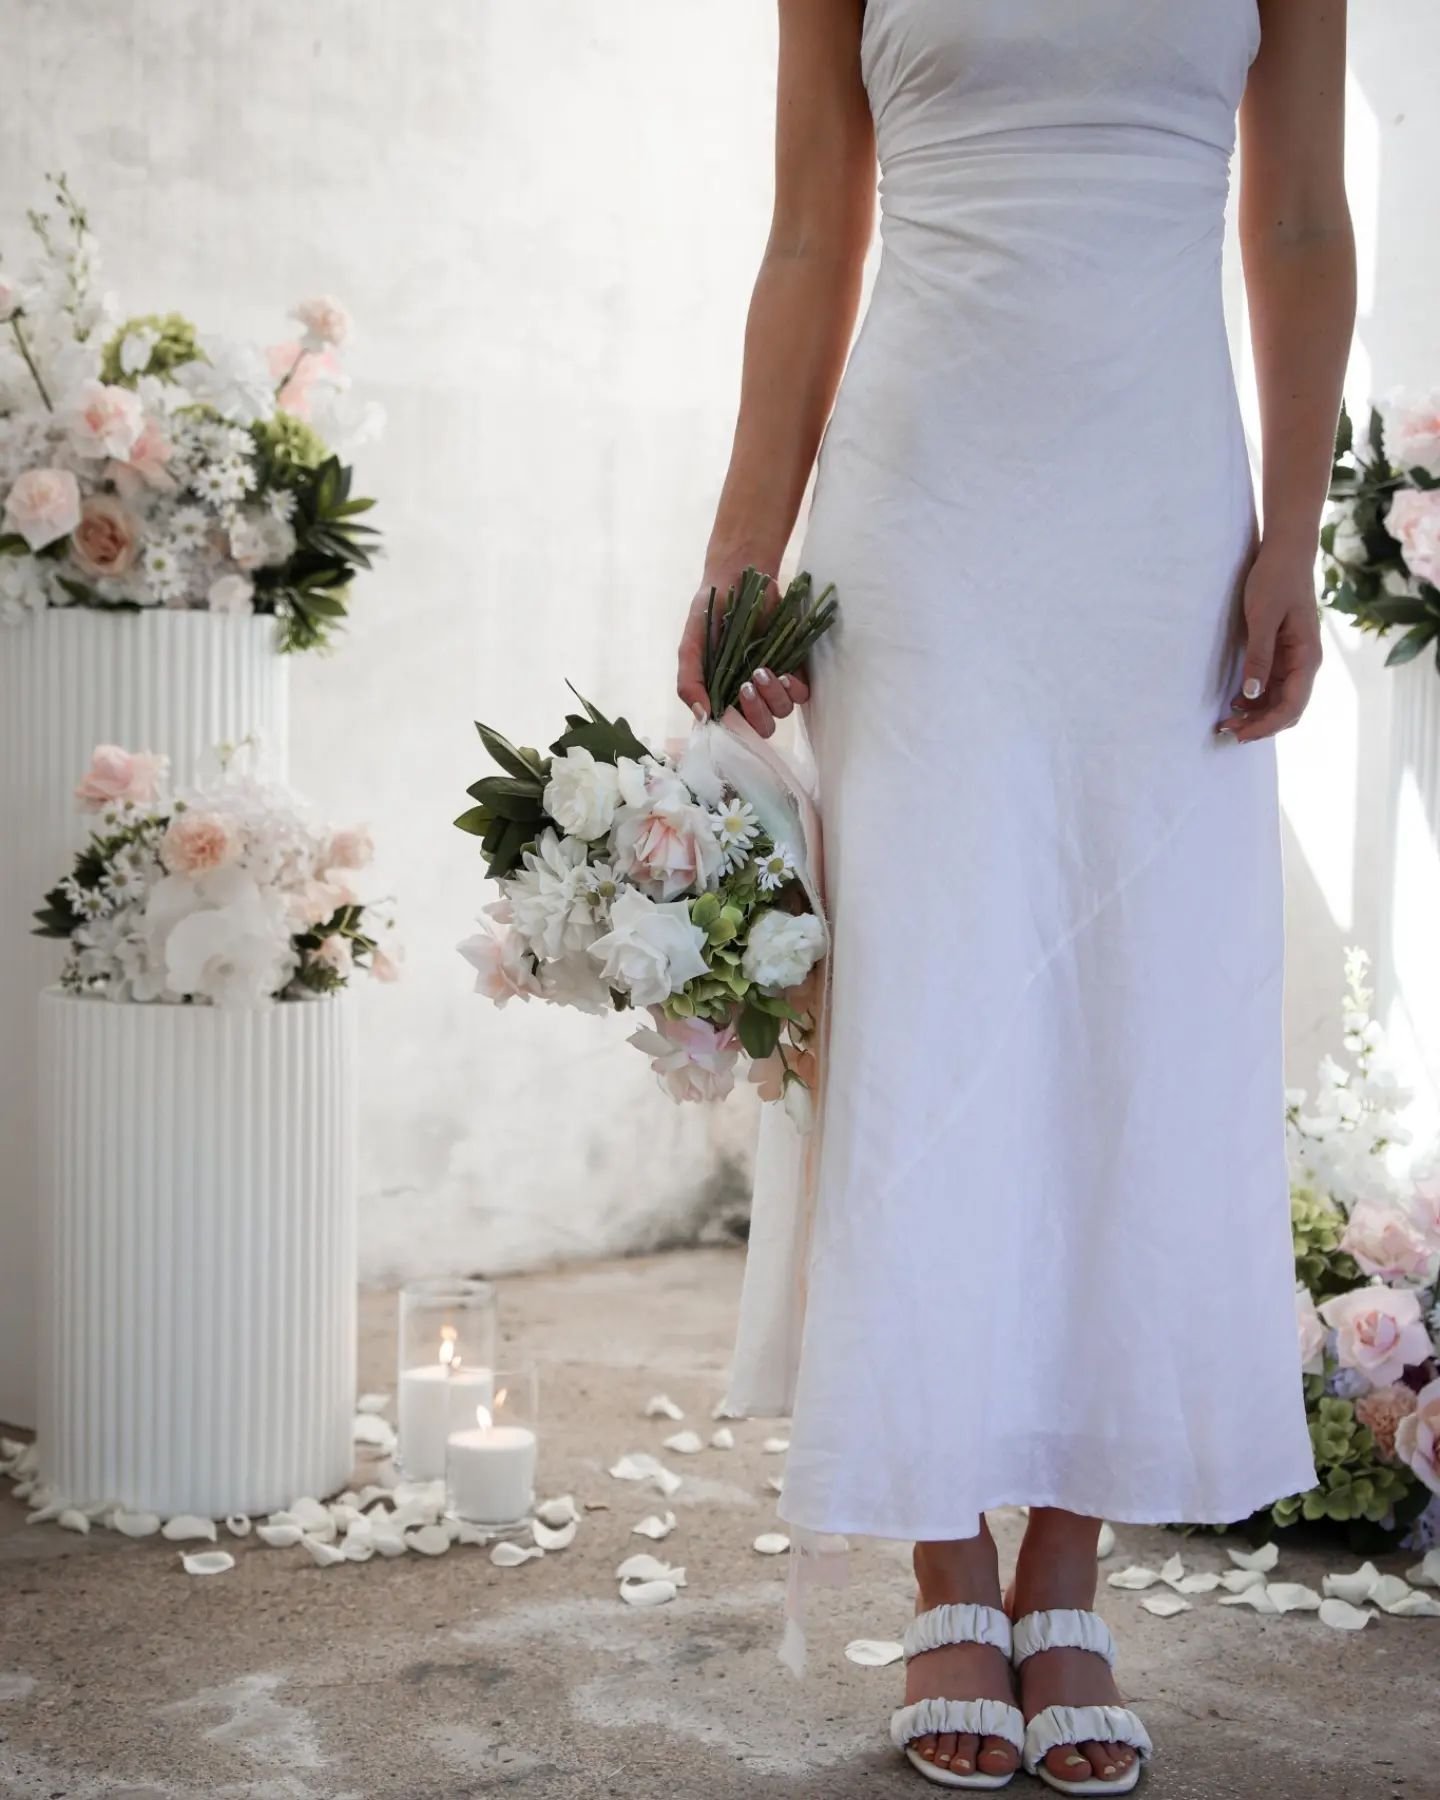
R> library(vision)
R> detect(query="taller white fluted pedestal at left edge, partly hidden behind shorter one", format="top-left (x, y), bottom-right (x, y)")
top-left (0, 607), bottom-right (288, 1426)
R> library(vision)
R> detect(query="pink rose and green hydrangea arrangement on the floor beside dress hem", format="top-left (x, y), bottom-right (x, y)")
top-left (1251, 950), bottom-right (1440, 1548)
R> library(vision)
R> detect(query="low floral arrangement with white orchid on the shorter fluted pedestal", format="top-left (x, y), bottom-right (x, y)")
top-left (36, 745), bottom-right (398, 1006)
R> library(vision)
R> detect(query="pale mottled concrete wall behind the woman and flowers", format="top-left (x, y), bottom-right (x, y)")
top-left (0, 0), bottom-right (1440, 1271)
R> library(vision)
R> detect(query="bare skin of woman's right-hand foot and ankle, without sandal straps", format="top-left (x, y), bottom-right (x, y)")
top-left (1004, 1507), bottom-right (1139, 1782)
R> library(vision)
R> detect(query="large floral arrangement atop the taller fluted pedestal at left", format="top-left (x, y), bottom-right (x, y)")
top-left (0, 178), bottom-right (380, 650)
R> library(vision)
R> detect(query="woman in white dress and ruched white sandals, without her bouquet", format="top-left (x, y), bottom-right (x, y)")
top-left (680, 0), bottom-right (1354, 1793)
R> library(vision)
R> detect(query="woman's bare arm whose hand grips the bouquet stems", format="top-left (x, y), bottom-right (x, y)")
top-left (677, 0), bottom-right (875, 736)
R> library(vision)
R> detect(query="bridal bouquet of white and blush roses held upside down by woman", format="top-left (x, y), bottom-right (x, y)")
top-left (455, 571), bottom-right (835, 1129)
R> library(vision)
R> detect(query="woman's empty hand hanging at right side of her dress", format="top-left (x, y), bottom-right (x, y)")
top-left (1215, 544), bottom-right (1321, 743)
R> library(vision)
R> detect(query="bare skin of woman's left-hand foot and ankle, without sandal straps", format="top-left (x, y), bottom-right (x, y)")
top-left (905, 1521), bottom-right (1021, 1775)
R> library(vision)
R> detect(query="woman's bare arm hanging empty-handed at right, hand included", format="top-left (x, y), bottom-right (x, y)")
top-left (1220, 0), bottom-right (1355, 742)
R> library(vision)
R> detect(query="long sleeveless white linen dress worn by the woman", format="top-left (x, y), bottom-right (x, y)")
top-left (729, 0), bottom-right (1314, 1539)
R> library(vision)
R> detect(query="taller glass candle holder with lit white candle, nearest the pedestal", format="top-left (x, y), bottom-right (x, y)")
top-left (396, 1276), bottom-right (497, 1481)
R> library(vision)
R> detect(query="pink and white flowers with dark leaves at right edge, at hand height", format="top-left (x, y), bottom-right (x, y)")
top-left (1319, 392), bottom-right (1440, 664)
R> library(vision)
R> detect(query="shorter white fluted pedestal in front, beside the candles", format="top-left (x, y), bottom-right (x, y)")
top-left (38, 990), bottom-right (356, 1517)
